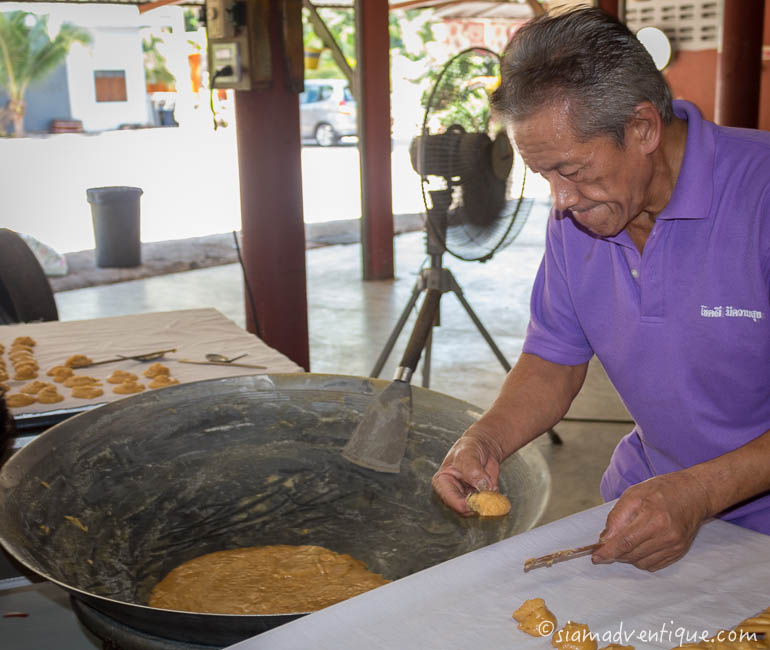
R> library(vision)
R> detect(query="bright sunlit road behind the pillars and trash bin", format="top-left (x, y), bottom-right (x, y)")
top-left (0, 128), bottom-right (422, 252)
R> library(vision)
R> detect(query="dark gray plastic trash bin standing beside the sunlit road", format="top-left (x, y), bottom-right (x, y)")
top-left (86, 187), bottom-right (142, 266)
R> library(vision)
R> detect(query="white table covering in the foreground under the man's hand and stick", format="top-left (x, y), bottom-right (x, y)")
top-left (231, 504), bottom-right (770, 650)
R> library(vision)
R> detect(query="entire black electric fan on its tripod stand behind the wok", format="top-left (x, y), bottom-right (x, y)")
top-left (371, 47), bottom-right (532, 387)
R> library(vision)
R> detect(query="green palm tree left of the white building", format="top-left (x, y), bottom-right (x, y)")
top-left (0, 11), bottom-right (92, 137)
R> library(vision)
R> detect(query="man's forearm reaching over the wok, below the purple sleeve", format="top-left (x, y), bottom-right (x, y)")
top-left (465, 354), bottom-right (588, 460)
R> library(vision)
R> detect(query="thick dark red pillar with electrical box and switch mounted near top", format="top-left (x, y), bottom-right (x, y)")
top-left (235, 0), bottom-right (310, 370)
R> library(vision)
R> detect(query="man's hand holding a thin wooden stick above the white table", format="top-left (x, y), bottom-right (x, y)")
top-left (592, 470), bottom-right (711, 571)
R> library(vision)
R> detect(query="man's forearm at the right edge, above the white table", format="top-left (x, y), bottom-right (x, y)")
top-left (683, 431), bottom-right (770, 516)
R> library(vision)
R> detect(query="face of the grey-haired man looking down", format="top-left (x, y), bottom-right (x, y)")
top-left (513, 98), bottom-right (652, 237)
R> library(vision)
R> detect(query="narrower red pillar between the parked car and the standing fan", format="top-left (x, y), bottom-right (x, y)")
top-left (355, 0), bottom-right (393, 280)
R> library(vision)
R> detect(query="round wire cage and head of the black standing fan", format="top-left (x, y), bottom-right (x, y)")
top-left (413, 47), bottom-right (532, 261)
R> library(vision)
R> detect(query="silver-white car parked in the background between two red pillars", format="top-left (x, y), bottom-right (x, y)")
top-left (299, 79), bottom-right (358, 147)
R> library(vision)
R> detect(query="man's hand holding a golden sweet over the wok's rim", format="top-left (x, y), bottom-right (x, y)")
top-left (432, 427), bottom-right (502, 516)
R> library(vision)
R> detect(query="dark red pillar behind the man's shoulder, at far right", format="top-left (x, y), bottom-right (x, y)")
top-left (715, 0), bottom-right (765, 129)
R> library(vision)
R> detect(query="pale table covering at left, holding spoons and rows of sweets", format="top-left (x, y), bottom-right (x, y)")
top-left (0, 309), bottom-right (303, 415)
